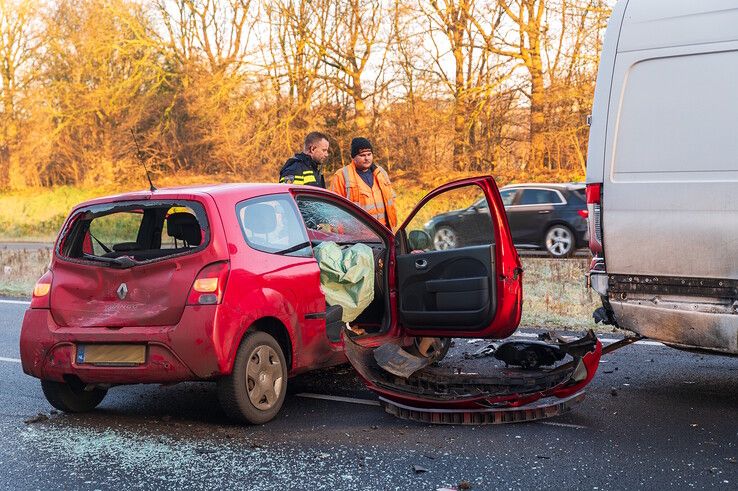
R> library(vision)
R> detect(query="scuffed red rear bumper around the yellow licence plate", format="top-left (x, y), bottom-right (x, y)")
top-left (20, 305), bottom-right (221, 385)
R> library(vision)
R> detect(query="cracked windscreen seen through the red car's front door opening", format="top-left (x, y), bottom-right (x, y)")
top-left (297, 196), bottom-right (384, 244)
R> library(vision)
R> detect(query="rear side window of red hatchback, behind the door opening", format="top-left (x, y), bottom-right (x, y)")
top-left (236, 194), bottom-right (312, 257)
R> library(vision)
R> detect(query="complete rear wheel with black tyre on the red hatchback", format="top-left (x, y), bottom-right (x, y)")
top-left (218, 331), bottom-right (287, 424)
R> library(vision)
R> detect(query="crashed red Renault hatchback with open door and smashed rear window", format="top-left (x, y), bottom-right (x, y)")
top-left (20, 177), bottom-right (600, 423)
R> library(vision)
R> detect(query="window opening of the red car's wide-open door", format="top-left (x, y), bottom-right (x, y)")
top-left (404, 184), bottom-right (494, 252)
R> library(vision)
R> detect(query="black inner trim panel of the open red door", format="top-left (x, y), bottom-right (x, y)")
top-left (397, 246), bottom-right (497, 330)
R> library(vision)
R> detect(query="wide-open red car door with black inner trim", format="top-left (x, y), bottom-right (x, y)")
top-left (396, 176), bottom-right (523, 339)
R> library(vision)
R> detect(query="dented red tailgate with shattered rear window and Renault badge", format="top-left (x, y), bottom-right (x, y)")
top-left (50, 197), bottom-right (218, 327)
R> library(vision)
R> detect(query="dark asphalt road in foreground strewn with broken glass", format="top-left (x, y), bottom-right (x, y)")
top-left (0, 300), bottom-right (738, 490)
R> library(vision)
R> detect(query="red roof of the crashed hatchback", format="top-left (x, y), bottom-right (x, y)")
top-left (75, 183), bottom-right (329, 208)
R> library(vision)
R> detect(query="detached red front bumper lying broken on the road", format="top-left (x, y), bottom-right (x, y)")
top-left (344, 331), bottom-right (602, 424)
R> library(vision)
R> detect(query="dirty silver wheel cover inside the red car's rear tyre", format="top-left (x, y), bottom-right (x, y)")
top-left (246, 346), bottom-right (284, 411)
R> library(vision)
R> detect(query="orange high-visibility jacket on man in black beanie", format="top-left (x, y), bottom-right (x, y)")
top-left (330, 162), bottom-right (397, 230)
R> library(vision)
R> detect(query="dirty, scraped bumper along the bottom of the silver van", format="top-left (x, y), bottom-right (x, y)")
top-left (610, 298), bottom-right (738, 355)
